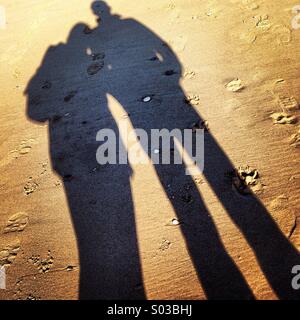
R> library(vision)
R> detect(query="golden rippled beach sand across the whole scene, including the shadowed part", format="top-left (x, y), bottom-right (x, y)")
top-left (0, 0), bottom-right (300, 299)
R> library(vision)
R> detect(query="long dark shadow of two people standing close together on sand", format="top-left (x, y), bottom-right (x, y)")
top-left (25, 1), bottom-right (299, 299)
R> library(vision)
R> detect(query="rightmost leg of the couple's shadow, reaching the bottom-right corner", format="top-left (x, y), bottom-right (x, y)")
top-left (204, 135), bottom-right (300, 299)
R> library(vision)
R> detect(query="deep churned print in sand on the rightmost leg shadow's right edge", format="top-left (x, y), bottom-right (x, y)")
top-left (228, 166), bottom-right (262, 195)
